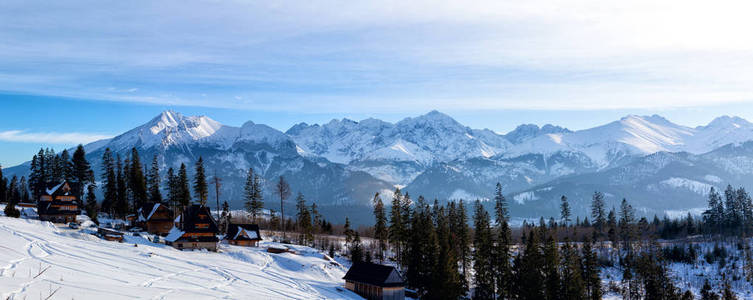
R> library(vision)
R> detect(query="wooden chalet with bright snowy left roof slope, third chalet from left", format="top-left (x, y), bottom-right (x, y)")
top-left (165, 204), bottom-right (220, 251)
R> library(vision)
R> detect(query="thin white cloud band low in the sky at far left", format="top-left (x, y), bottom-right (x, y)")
top-left (0, 130), bottom-right (111, 144)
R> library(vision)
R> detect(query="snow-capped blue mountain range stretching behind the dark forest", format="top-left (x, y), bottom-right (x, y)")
top-left (6, 111), bottom-right (753, 222)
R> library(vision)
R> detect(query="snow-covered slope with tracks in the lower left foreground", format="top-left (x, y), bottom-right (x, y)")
top-left (0, 216), bottom-right (362, 300)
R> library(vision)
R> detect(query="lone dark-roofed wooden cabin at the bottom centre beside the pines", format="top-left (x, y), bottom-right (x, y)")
top-left (343, 262), bottom-right (405, 300)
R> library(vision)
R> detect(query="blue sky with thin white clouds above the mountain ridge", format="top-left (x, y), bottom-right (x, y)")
top-left (0, 0), bottom-right (753, 166)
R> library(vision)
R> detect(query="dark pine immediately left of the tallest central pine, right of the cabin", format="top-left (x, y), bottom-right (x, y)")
top-left (473, 200), bottom-right (495, 299)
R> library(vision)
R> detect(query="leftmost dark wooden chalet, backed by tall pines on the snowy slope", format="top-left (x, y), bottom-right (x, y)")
top-left (37, 181), bottom-right (81, 223)
